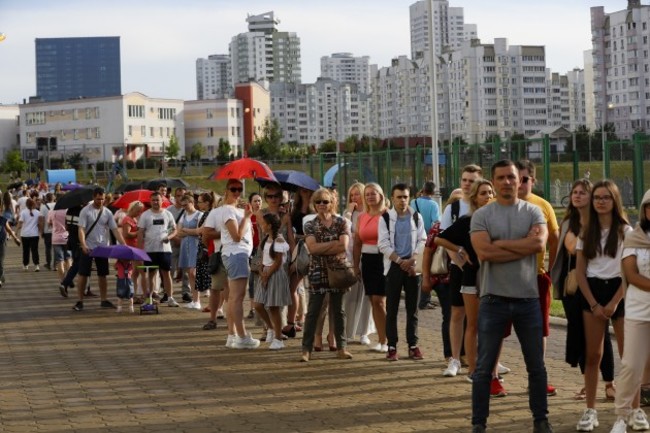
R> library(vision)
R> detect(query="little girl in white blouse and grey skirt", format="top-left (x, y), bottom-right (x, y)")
top-left (253, 213), bottom-right (291, 350)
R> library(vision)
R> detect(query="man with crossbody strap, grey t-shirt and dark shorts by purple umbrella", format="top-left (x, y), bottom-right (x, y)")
top-left (73, 187), bottom-right (124, 311)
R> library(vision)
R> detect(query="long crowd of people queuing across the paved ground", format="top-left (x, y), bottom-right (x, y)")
top-left (0, 160), bottom-right (650, 433)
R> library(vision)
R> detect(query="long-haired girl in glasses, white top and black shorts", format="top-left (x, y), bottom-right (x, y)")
top-left (576, 179), bottom-right (632, 431)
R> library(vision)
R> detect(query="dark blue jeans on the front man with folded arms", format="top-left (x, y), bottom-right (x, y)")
top-left (472, 295), bottom-right (548, 426)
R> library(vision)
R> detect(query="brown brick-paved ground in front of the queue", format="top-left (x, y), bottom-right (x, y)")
top-left (0, 245), bottom-right (614, 433)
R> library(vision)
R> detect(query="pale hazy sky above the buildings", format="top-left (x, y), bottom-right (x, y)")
top-left (0, 0), bottom-right (624, 104)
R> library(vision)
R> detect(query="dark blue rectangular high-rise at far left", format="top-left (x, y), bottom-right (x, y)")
top-left (36, 36), bottom-right (122, 102)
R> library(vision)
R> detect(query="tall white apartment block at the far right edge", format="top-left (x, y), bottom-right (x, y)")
top-left (591, 0), bottom-right (650, 138)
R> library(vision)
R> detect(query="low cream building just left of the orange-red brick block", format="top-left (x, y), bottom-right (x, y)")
top-left (184, 99), bottom-right (244, 159)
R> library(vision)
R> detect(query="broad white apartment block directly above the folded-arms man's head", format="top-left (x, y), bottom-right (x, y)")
top-left (446, 38), bottom-right (548, 143)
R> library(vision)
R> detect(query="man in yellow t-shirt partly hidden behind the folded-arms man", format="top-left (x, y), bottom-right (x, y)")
top-left (517, 159), bottom-right (560, 396)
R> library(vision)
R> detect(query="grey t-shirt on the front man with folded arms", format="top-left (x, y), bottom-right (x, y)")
top-left (470, 200), bottom-right (546, 298)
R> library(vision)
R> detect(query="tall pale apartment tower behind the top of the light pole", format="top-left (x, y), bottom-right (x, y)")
top-left (409, 0), bottom-right (477, 59)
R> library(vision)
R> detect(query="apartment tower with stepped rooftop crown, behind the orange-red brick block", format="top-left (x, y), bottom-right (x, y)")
top-left (229, 12), bottom-right (302, 85)
